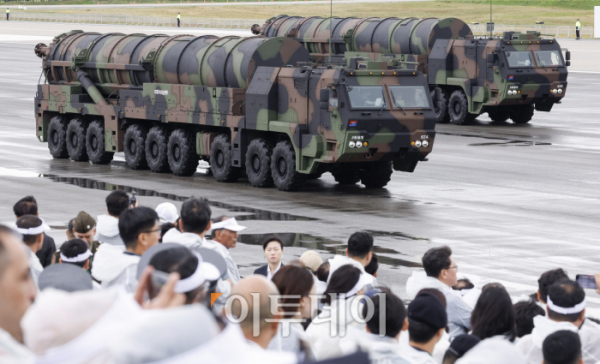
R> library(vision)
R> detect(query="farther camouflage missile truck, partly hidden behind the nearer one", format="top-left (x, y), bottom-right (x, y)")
top-left (252, 15), bottom-right (570, 124)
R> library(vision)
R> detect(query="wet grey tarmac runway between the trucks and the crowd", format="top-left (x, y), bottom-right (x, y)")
top-left (0, 23), bottom-right (600, 308)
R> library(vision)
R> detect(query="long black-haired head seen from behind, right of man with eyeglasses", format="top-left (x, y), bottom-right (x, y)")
top-left (471, 284), bottom-right (516, 342)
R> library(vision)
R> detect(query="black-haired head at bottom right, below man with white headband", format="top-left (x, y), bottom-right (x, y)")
top-left (542, 330), bottom-right (581, 364)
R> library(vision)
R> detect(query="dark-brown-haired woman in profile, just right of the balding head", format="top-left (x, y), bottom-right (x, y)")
top-left (268, 265), bottom-right (316, 361)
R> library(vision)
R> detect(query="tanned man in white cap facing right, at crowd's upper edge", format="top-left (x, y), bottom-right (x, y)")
top-left (212, 216), bottom-right (246, 283)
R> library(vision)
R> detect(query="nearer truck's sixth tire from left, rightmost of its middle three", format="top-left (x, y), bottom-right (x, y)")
top-left (167, 129), bottom-right (199, 176)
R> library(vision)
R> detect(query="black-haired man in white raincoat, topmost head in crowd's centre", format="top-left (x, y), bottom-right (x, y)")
top-left (329, 231), bottom-right (375, 288)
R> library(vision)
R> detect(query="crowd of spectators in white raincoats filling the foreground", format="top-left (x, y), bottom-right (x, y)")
top-left (0, 191), bottom-right (600, 364)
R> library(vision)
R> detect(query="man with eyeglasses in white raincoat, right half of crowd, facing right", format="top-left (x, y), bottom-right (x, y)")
top-left (406, 246), bottom-right (473, 338)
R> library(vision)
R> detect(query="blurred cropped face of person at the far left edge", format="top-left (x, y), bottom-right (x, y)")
top-left (0, 225), bottom-right (36, 364)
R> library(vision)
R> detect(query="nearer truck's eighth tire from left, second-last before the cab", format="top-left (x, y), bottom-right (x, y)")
top-left (246, 138), bottom-right (273, 187)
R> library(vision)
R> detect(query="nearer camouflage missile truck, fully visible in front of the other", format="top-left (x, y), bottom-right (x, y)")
top-left (35, 31), bottom-right (435, 191)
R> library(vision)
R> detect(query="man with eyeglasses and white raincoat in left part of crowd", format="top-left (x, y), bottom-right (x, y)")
top-left (92, 207), bottom-right (160, 292)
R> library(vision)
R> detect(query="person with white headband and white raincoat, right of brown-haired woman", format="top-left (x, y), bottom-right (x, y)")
top-left (306, 264), bottom-right (371, 360)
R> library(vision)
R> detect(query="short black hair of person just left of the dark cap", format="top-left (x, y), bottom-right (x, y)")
top-left (362, 288), bottom-right (406, 337)
